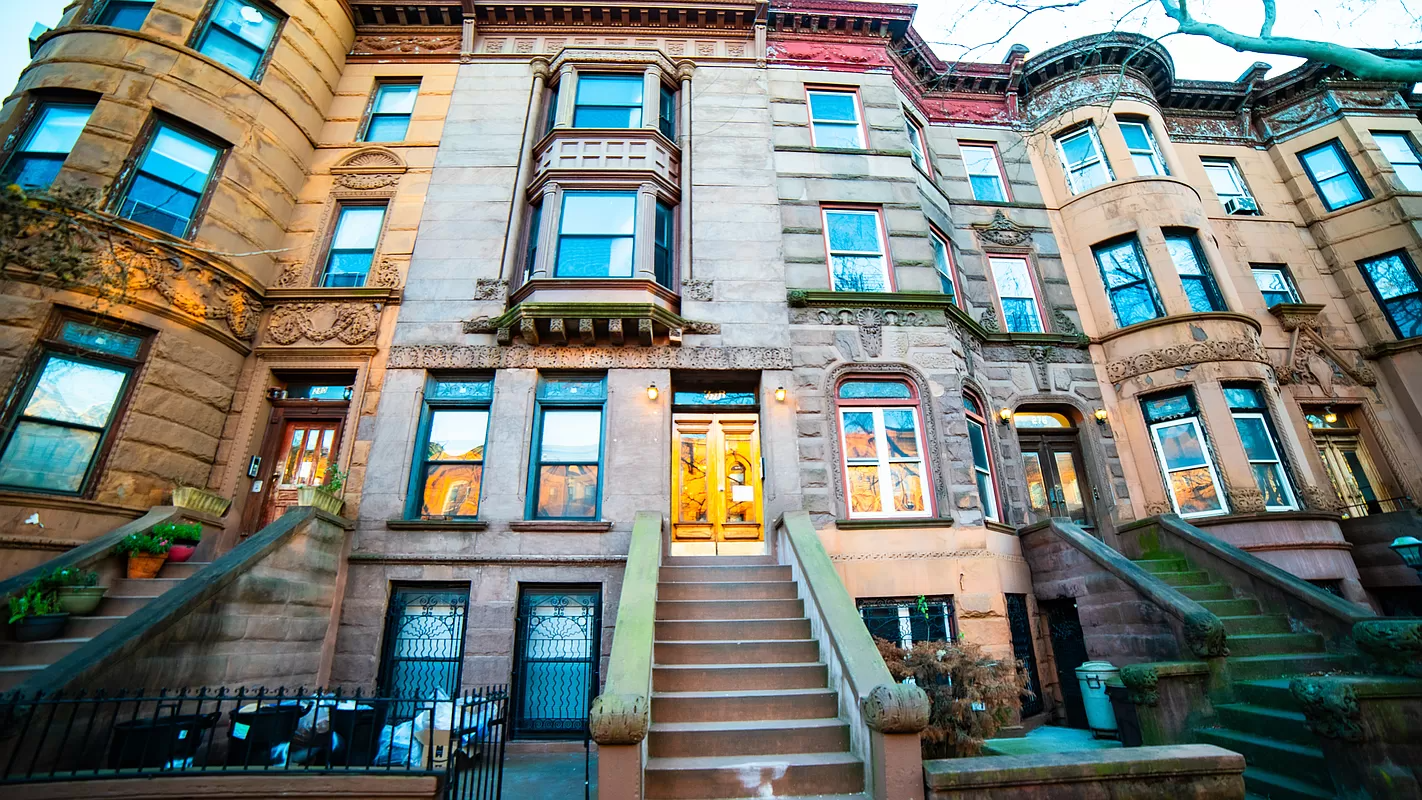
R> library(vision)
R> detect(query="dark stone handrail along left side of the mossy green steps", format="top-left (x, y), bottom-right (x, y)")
top-left (1018, 520), bottom-right (1229, 658)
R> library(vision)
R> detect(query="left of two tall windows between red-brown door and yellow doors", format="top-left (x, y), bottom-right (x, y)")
top-left (410, 378), bottom-right (493, 519)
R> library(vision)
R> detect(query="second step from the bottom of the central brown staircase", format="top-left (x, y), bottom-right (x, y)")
top-left (647, 719), bottom-right (849, 759)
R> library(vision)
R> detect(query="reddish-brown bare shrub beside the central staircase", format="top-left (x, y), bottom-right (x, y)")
top-left (875, 637), bottom-right (1028, 759)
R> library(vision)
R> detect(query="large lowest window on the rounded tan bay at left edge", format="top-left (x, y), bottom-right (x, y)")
top-left (0, 315), bottom-right (148, 494)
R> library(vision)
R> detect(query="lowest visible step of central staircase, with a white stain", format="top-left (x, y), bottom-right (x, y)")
top-left (646, 753), bottom-right (865, 799)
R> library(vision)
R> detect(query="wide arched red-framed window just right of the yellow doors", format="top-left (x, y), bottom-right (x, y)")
top-left (838, 379), bottom-right (933, 519)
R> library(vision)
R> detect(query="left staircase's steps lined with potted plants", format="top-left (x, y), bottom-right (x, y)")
top-left (0, 561), bottom-right (208, 693)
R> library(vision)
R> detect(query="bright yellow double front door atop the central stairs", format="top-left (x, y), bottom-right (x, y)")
top-left (671, 413), bottom-right (765, 550)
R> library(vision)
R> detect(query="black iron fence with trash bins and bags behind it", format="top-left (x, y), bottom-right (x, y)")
top-left (0, 686), bottom-right (508, 800)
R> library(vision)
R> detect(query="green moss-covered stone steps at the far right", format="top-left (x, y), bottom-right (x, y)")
top-left (1136, 553), bottom-right (1351, 800)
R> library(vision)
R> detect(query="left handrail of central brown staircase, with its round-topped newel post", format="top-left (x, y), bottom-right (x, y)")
top-left (587, 512), bottom-right (663, 797)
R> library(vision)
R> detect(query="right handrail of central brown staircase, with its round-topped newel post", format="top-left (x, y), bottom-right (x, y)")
top-left (775, 512), bottom-right (929, 799)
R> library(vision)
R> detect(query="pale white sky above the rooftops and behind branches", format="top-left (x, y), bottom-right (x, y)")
top-left (0, 0), bottom-right (1422, 95)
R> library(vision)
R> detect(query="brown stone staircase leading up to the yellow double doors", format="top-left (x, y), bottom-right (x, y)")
top-left (646, 556), bottom-right (865, 800)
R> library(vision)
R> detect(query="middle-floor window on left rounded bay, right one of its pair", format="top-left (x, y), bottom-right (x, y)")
top-left (118, 124), bottom-right (222, 239)
